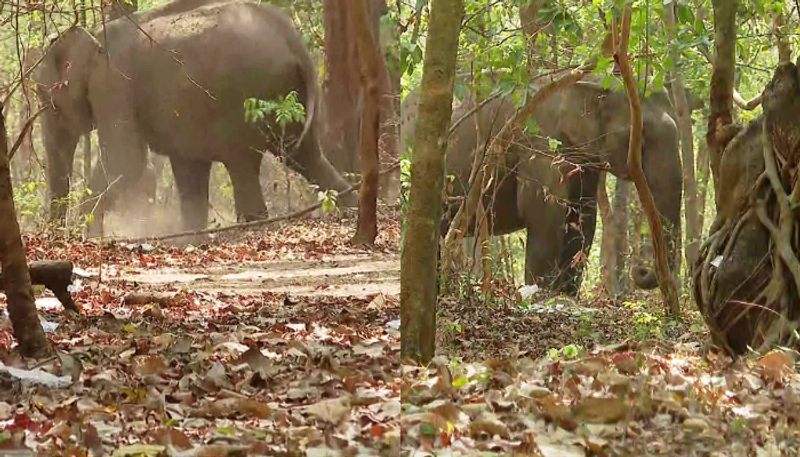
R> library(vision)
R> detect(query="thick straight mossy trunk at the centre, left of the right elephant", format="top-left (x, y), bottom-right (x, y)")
top-left (400, 0), bottom-right (464, 363)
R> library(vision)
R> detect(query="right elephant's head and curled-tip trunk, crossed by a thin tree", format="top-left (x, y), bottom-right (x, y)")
top-left (548, 82), bottom-right (683, 289)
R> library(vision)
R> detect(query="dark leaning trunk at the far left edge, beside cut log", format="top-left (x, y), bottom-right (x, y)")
top-left (0, 104), bottom-right (51, 358)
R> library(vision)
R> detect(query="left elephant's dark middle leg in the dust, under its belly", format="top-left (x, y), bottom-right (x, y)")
top-left (169, 156), bottom-right (211, 230)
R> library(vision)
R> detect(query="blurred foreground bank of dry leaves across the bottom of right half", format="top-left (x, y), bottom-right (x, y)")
top-left (401, 342), bottom-right (800, 457)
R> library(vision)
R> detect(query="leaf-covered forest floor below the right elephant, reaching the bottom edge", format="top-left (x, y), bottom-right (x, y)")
top-left (401, 287), bottom-right (800, 457)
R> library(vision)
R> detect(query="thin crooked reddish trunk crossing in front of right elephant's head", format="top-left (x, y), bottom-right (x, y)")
top-left (613, 3), bottom-right (680, 316)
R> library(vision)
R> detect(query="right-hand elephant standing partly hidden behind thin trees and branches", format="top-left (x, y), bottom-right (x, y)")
top-left (404, 81), bottom-right (683, 295)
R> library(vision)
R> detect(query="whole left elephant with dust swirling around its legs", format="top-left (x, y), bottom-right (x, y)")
top-left (34, 0), bottom-right (354, 230)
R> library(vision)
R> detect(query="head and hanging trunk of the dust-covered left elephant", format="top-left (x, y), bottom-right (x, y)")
top-left (34, 27), bottom-right (100, 222)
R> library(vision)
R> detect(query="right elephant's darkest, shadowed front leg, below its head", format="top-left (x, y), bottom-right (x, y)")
top-left (553, 169), bottom-right (599, 296)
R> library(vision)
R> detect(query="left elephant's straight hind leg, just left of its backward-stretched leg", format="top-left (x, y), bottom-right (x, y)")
top-left (225, 154), bottom-right (267, 221)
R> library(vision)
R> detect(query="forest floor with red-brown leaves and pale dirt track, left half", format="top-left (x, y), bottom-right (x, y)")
top-left (0, 211), bottom-right (401, 457)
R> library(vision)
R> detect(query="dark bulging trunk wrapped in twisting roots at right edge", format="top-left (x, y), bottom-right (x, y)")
top-left (694, 95), bottom-right (800, 354)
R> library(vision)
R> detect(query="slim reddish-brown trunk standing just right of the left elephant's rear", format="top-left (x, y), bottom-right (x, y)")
top-left (349, 0), bottom-right (386, 245)
